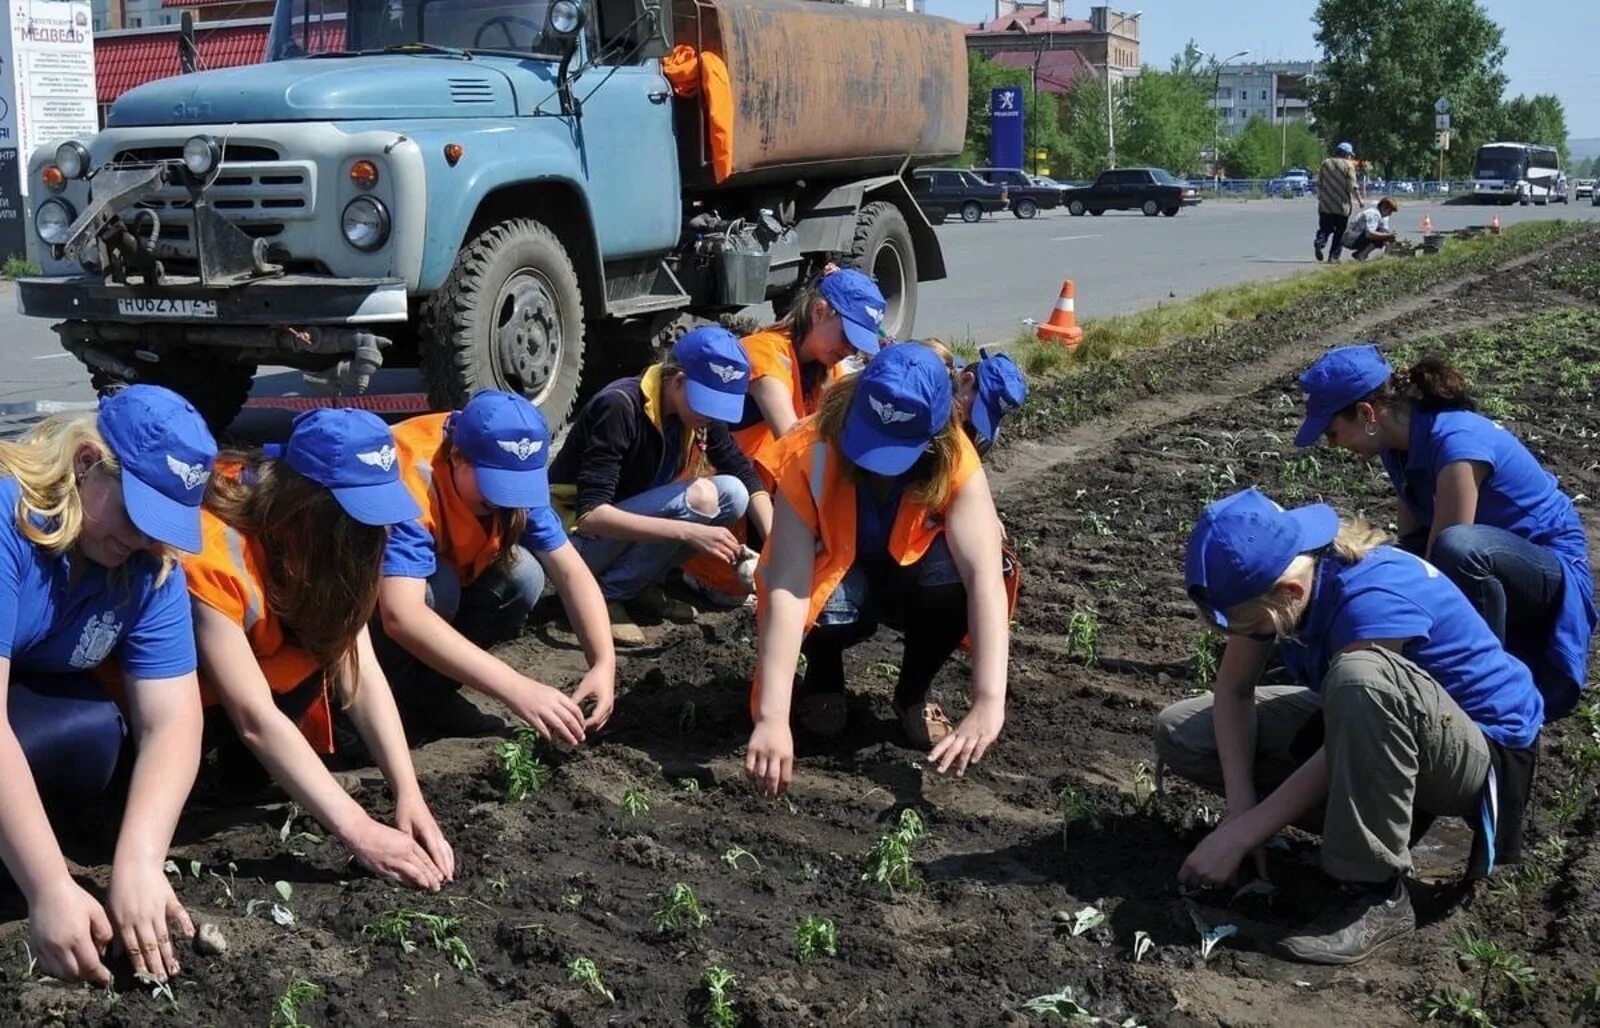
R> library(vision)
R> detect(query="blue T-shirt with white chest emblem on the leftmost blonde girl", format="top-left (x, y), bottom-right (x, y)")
top-left (0, 477), bottom-right (195, 679)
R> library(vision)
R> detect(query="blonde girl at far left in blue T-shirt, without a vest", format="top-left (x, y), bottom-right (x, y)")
top-left (0, 386), bottom-right (216, 985)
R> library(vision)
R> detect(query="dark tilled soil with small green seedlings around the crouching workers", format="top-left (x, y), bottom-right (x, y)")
top-left (0, 225), bottom-right (1600, 1026)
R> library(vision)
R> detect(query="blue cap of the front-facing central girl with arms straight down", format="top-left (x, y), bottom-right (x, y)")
top-left (838, 341), bottom-right (952, 476)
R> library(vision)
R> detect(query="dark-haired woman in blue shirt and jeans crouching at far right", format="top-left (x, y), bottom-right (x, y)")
top-left (1294, 344), bottom-right (1597, 710)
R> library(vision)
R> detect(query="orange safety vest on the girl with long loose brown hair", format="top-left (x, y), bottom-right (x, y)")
top-left (184, 509), bottom-right (333, 754)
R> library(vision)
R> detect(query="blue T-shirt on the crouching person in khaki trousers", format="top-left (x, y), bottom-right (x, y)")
top-left (1280, 546), bottom-right (1544, 748)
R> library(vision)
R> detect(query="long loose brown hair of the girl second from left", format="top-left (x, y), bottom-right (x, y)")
top-left (205, 452), bottom-right (389, 705)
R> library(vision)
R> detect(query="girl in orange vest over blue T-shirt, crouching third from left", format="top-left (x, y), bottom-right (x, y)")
top-left (374, 391), bottom-right (616, 746)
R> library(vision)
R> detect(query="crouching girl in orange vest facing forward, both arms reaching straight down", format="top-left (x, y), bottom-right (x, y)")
top-left (746, 343), bottom-right (1010, 796)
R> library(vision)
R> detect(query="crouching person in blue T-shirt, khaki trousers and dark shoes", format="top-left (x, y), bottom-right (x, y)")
top-left (1155, 490), bottom-right (1544, 964)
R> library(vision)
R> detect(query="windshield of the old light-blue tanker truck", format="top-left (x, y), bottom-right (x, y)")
top-left (267, 0), bottom-right (560, 61)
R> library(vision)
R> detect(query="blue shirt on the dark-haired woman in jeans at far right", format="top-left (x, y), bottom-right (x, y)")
top-left (1381, 403), bottom-right (1600, 713)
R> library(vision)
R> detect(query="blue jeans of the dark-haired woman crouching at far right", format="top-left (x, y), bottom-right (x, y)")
top-left (1432, 525), bottom-right (1566, 679)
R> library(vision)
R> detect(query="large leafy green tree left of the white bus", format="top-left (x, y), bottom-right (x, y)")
top-left (1310, 0), bottom-right (1506, 176)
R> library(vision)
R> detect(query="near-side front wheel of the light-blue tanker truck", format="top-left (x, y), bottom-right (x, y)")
top-left (421, 218), bottom-right (584, 428)
